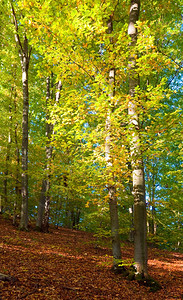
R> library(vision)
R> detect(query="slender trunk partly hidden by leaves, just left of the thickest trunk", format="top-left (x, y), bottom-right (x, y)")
top-left (105, 17), bottom-right (121, 271)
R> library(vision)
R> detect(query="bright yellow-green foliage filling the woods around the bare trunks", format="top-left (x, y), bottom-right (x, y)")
top-left (0, 0), bottom-right (183, 251)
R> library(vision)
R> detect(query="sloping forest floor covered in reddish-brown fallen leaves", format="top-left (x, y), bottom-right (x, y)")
top-left (0, 218), bottom-right (183, 300)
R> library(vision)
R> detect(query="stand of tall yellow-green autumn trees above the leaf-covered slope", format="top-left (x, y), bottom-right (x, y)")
top-left (0, 0), bottom-right (183, 299)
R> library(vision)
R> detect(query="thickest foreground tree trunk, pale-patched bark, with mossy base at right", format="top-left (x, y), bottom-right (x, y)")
top-left (128, 0), bottom-right (147, 277)
